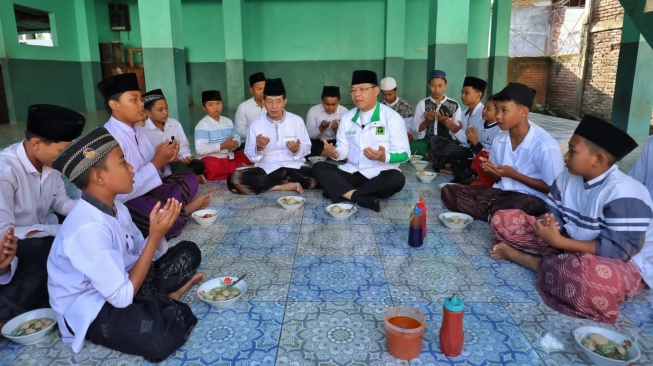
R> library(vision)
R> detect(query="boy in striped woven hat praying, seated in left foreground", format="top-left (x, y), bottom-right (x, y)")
top-left (48, 127), bottom-right (204, 362)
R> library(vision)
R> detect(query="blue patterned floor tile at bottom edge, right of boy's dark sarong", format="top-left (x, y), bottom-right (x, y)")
top-left (164, 301), bottom-right (284, 366)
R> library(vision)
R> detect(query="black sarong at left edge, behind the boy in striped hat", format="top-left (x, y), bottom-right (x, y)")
top-left (0, 236), bottom-right (54, 322)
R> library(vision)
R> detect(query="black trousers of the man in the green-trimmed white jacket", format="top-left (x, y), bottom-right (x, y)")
top-left (313, 162), bottom-right (406, 202)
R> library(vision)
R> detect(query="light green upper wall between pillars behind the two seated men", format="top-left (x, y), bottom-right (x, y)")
top-left (243, 0), bottom-right (385, 62)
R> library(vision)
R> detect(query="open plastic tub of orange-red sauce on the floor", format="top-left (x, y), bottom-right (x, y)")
top-left (384, 306), bottom-right (426, 360)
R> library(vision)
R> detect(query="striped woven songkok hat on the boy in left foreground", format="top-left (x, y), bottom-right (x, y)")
top-left (52, 127), bottom-right (118, 182)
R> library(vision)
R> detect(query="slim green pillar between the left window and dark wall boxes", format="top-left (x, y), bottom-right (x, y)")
top-left (74, 0), bottom-right (103, 111)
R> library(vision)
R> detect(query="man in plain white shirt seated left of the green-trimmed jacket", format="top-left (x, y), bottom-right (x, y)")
top-left (227, 79), bottom-right (317, 194)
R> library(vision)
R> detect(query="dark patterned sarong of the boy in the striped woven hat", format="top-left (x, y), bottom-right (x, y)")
top-left (86, 241), bottom-right (202, 362)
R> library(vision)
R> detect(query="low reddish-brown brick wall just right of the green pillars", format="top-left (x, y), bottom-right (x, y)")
top-left (508, 57), bottom-right (549, 104)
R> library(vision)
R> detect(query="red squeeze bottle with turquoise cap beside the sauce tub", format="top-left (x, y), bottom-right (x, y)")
top-left (440, 295), bottom-right (465, 357)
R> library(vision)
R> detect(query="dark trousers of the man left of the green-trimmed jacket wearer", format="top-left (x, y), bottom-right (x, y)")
top-left (227, 167), bottom-right (318, 194)
